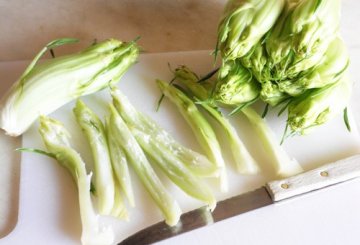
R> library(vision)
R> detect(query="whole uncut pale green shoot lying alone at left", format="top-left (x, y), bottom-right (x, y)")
top-left (0, 39), bottom-right (139, 136)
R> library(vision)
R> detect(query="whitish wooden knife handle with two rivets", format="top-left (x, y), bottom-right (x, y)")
top-left (266, 154), bottom-right (360, 201)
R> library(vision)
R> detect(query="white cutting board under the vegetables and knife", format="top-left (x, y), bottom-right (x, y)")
top-left (0, 51), bottom-right (360, 244)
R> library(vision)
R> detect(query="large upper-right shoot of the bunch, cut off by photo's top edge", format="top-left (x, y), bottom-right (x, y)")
top-left (265, 0), bottom-right (340, 81)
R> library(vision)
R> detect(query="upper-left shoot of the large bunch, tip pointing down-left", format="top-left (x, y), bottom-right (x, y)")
top-left (217, 0), bottom-right (285, 60)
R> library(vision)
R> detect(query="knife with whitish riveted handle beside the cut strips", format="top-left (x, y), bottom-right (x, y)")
top-left (118, 154), bottom-right (360, 245)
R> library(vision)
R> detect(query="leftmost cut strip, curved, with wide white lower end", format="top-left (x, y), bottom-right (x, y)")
top-left (39, 116), bottom-right (114, 245)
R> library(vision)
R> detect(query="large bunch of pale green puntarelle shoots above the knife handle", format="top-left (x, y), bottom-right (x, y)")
top-left (213, 0), bottom-right (351, 134)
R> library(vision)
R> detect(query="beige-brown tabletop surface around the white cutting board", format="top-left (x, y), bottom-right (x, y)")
top-left (0, 0), bottom-right (360, 243)
